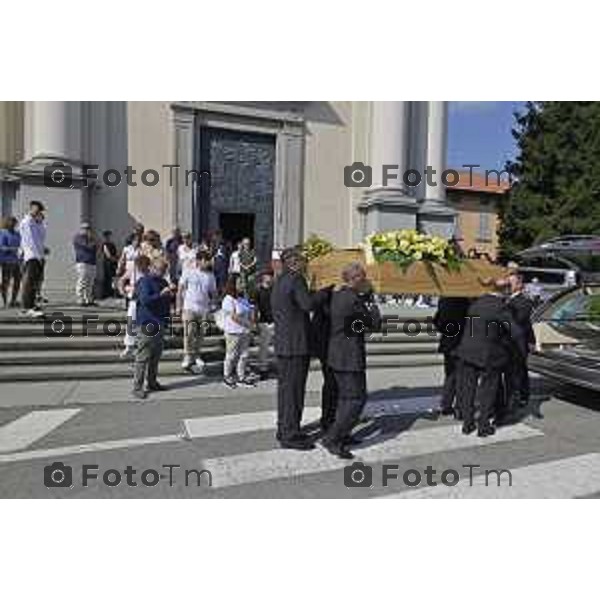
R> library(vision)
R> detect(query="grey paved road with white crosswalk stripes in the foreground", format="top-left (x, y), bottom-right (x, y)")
top-left (0, 369), bottom-right (600, 499)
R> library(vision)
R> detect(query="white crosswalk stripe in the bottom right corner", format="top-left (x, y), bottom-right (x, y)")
top-left (379, 453), bottom-right (600, 500)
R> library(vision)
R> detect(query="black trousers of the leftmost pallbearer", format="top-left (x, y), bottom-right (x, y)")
top-left (277, 356), bottom-right (310, 440)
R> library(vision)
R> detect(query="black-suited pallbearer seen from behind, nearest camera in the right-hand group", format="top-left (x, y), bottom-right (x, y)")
top-left (456, 279), bottom-right (522, 437)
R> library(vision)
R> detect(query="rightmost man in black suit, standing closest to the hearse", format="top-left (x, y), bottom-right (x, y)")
top-left (506, 273), bottom-right (535, 406)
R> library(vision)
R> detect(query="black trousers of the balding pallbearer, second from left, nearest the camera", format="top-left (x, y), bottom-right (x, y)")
top-left (324, 371), bottom-right (367, 446)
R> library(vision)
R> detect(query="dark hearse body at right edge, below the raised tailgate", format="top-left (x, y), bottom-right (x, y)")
top-left (529, 284), bottom-right (600, 392)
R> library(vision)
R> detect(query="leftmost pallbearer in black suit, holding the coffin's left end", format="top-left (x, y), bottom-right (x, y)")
top-left (271, 248), bottom-right (323, 450)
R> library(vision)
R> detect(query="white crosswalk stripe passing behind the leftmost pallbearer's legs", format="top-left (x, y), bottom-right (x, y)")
top-left (182, 406), bottom-right (321, 439)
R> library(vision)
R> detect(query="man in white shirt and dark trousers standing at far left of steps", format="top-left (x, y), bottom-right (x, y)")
top-left (19, 200), bottom-right (47, 317)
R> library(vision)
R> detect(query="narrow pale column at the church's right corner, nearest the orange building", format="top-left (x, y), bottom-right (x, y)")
top-left (418, 101), bottom-right (456, 238)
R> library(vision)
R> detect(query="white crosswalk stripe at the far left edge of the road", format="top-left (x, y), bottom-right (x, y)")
top-left (0, 408), bottom-right (81, 452)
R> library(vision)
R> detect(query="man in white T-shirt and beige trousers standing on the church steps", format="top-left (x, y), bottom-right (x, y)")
top-left (178, 250), bottom-right (217, 372)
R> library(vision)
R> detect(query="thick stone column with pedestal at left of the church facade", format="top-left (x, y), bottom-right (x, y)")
top-left (15, 102), bottom-right (86, 300)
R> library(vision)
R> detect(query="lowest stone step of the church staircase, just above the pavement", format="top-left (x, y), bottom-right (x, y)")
top-left (0, 354), bottom-right (442, 383)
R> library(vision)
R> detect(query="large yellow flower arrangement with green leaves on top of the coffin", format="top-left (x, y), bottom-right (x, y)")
top-left (361, 229), bottom-right (462, 271)
